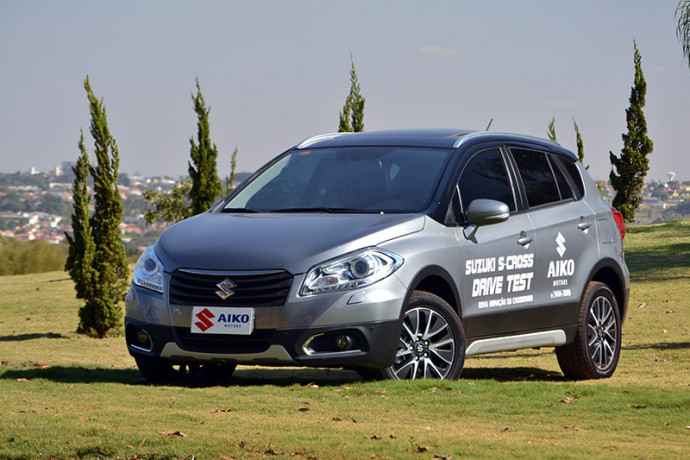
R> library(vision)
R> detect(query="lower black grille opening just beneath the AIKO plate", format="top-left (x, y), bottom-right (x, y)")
top-left (175, 327), bottom-right (275, 353)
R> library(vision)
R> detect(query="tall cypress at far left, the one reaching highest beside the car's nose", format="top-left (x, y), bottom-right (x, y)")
top-left (77, 77), bottom-right (129, 337)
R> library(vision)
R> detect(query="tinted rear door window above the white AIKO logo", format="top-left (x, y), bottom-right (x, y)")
top-left (511, 149), bottom-right (561, 207)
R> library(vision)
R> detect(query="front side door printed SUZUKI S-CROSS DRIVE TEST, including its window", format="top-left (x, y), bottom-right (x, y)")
top-left (454, 147), bottom-right (535, 340)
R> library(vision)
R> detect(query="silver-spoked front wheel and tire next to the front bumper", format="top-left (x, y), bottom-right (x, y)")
top-left (374, 291), bottom-right (465, 380)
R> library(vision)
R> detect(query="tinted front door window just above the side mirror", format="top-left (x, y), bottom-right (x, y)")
top-left (458, 149), bottom-right (515, 211)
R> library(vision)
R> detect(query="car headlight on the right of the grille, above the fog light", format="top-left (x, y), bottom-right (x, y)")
top-left (300, 248), bottom-right (403, 296)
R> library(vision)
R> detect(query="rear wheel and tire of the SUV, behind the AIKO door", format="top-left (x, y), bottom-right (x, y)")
top-left (556, 281), bottom-right (621, 380)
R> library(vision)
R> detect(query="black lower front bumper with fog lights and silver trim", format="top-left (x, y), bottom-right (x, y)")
top-left (125, 317), bottom-right (400, 368)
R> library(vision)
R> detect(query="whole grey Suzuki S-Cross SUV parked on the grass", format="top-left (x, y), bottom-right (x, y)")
top-left (125, 130), bottom-right (630, 382)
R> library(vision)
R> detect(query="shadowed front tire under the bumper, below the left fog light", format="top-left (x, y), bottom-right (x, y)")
top-left (135, 357), bottom-right (237, 384)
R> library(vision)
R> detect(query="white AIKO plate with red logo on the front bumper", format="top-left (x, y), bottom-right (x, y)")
top-left (191, 307), bottom-right (254, 335)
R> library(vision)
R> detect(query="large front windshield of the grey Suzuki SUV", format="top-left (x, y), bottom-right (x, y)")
top-left (222, 147), bottom-right (451, 213)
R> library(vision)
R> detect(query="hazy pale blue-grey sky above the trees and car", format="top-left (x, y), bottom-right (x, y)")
top-left (0, 0), bottom-right (690, 180)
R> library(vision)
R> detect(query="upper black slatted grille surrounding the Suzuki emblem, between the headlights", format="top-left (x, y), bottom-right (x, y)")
top-left (170, 269), bottom-right (292, 307)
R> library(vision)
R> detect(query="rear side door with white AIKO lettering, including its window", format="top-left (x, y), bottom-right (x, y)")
top-left (510, 147), bottom-right (599, 330)
